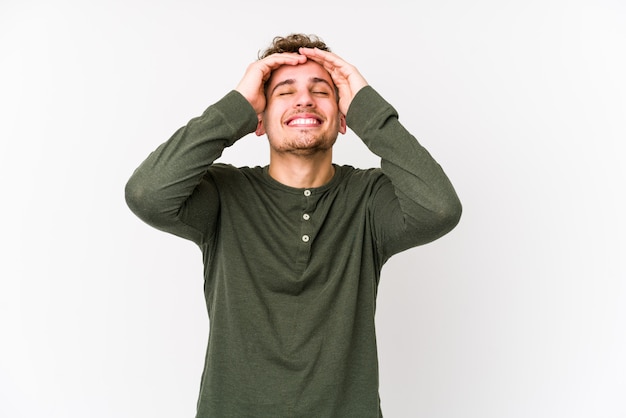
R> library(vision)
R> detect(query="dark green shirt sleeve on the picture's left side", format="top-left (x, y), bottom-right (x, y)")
top-left (125, 90), bottom-right (257, 243)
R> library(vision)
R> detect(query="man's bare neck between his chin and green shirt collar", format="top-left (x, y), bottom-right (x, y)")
top-left (269, 150), bottom-right (335, 188)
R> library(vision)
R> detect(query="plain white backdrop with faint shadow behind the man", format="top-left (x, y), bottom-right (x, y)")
top-left (0, 0), bottom-right (626, 418)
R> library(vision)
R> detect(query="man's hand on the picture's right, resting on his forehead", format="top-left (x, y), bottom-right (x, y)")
top-left (300, 48), bottom-right (368, 115)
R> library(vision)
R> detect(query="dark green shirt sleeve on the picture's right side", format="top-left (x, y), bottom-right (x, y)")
top-left (346, 86), bottom-right (461, 260)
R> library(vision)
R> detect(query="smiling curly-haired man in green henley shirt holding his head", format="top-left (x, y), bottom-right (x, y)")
top-left (126, 34), bottom-right (461, 418)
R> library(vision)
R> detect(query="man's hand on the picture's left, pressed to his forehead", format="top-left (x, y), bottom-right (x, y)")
top-left (235, 53), bottom-right (307, 114)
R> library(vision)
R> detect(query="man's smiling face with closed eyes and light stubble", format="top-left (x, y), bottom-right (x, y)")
top-left (257, 61), bottom-right (346, 155)
